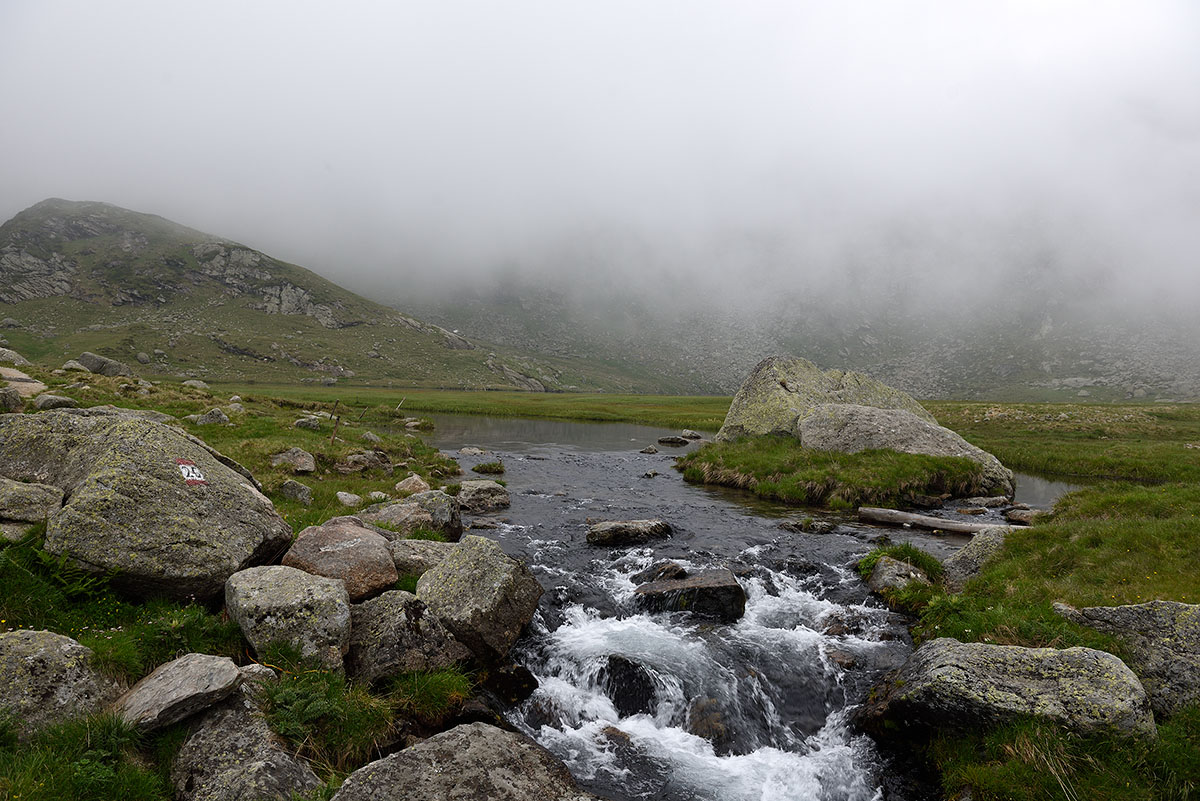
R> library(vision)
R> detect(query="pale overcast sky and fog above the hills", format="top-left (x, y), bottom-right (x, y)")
top-left (0, 0), bottom-right (1200, 302)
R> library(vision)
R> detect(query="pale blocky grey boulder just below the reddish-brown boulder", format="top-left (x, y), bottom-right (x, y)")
top-left (226, 565), bottom-right (350, 670)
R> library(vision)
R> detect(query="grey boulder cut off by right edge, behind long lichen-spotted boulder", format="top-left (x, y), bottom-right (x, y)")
top-left (1055, 601), bottom-right (1200, 716)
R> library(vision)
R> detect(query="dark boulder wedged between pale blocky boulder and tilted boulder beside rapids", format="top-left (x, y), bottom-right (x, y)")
top-left (346, 590), bottom-right (470, 681)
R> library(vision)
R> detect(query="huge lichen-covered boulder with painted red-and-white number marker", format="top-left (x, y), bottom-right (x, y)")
top-left (0, 411), bottom-right (292, 598)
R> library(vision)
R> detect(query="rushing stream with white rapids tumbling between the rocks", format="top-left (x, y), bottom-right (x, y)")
top-left (432, 415), bottom-right (1080, 801)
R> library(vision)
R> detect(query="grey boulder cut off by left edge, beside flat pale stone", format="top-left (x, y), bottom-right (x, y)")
top-left (0, 630), bottom-right (120, 739)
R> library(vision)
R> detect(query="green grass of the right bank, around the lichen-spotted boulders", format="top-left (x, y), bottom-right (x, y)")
top-left (868, 403), bottom-right (1200, 801)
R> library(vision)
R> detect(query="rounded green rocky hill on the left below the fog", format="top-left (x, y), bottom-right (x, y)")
top-left (0, 199), bottom-right (654, 391)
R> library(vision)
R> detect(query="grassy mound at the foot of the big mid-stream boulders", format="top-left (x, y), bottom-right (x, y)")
top-left (677, 436), bottom-right (984, 508)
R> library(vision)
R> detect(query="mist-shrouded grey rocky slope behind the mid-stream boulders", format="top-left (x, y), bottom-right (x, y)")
top-left (408, 278), bottom-right (1200, 402)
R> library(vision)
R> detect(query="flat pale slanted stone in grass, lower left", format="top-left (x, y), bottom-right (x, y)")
top-left (113, 654), bottom-right (241, 731)
